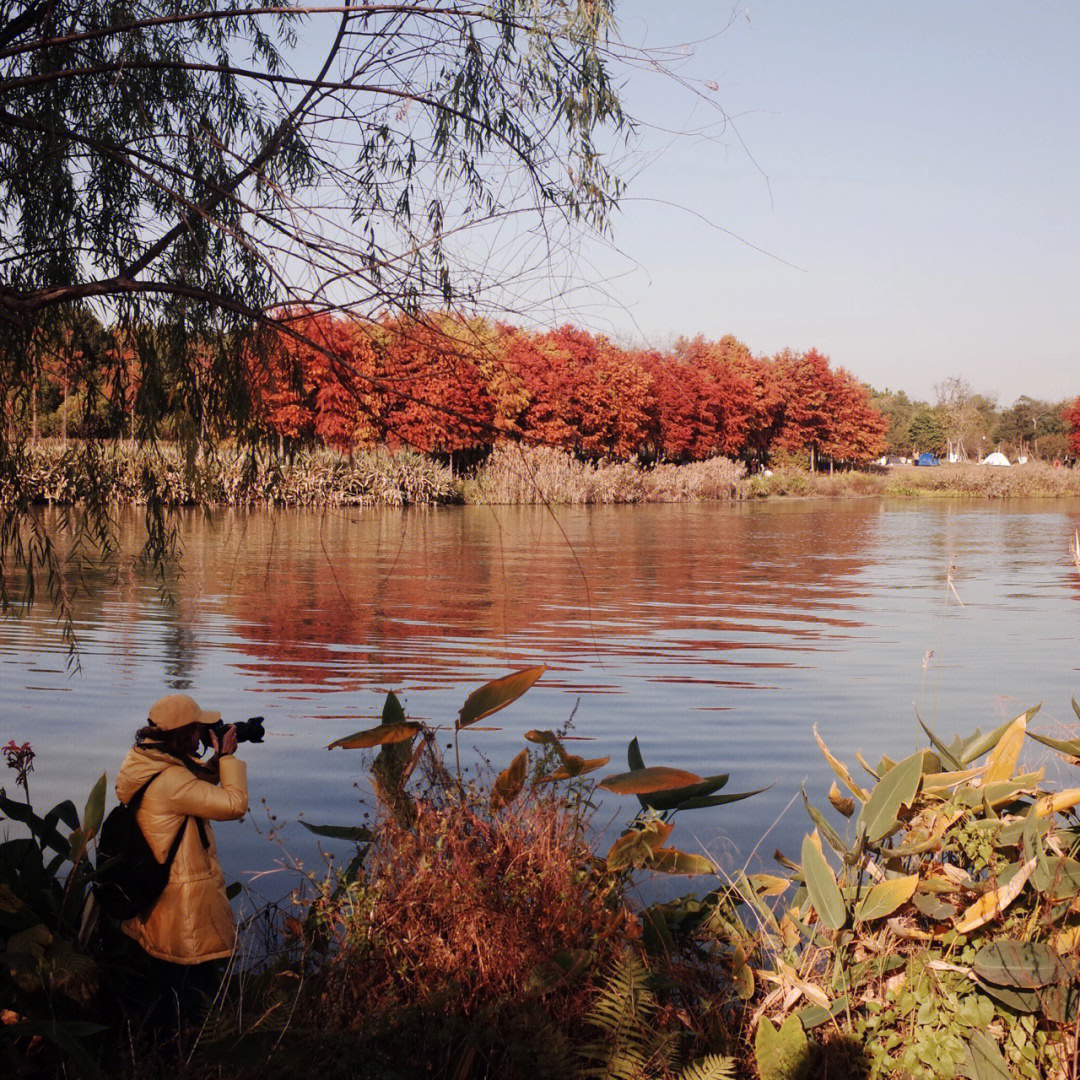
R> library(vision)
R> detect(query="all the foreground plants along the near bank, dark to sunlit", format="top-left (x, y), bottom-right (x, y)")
top-left (6, 669), bottom-right (1080, 1080)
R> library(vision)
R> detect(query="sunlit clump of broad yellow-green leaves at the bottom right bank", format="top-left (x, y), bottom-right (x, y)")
top-left (729, 702), bottom-right (1080, 1080)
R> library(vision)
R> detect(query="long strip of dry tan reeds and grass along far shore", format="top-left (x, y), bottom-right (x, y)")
top-left (8, 442), bottom-right (1080, 507)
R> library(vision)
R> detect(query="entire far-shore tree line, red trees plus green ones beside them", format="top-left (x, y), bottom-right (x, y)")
top-left (9, 312), bottom-right (1080, 486)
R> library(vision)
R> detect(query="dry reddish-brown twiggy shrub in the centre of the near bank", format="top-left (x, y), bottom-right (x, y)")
top-left (308, 799), bottom-right (621, 1029)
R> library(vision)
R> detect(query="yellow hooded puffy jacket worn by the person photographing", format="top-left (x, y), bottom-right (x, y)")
top-left (117, 746), bottom-right (247, 963)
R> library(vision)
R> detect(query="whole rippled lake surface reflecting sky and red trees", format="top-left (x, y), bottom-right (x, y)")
top-left (0, 500), bottom-right (1080, 902)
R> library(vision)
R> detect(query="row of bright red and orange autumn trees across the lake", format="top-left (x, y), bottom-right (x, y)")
top-left (252, 312), bottom-right (888, 461)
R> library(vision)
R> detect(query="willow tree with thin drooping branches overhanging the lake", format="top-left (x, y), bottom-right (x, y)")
top-left (0, 0), bottom-right (625, 630)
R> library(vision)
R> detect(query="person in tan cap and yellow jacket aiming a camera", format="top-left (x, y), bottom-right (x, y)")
top-left (116, 693), bottom-right (247, 1020)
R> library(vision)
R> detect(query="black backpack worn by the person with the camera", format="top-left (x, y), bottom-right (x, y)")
top-left (94, 773), bottom-right (191, 920)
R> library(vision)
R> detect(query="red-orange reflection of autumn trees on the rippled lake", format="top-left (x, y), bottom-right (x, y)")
top-left (210, 504), bottom-right (867, 689)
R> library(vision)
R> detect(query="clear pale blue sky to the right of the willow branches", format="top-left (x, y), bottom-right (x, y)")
top-left (589, 0), bottom-right (1080, 404)
